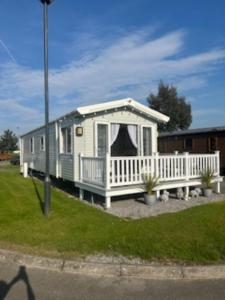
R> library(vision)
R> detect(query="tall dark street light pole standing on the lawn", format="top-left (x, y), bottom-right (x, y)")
top-left (40, 0), bottom-right (53, 216)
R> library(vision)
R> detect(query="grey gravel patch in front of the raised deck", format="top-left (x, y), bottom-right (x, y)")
top-left (107, 193), bottom-right (225, 219)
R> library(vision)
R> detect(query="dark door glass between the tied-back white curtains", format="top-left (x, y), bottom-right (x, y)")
top-left (111, 124), bottom-right (137, 156)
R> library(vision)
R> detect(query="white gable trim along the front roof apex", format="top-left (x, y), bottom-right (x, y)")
top-left (77, 98), bottom-right (169, 123)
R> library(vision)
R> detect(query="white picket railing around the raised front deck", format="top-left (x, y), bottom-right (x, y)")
top-left (80, 151), bottom-right (220, 188)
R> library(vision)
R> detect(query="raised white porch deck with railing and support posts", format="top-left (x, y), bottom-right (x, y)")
top-left (75, 151), bottom-right (222, 208)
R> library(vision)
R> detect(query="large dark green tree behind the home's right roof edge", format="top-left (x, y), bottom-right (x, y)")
top-left (147, 81), bottom-right (192, 132)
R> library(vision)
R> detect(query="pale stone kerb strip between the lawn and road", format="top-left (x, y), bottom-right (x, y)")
top-left (0, 249), bottom-right (225, 280)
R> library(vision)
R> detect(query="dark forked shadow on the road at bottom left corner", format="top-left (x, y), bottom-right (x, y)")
top-left (0, 266), bottom-right (35, 300)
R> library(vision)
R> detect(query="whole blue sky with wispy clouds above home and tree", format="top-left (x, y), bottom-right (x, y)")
top-left (0, 0), bottom-right (225, 134)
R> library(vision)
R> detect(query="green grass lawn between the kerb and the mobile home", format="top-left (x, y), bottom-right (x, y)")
top-left (0, 166), bottom-right (225, 263)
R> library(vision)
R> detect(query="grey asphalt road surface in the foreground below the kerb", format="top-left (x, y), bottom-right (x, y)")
top-left (0, 262), bottom-right (225, 300)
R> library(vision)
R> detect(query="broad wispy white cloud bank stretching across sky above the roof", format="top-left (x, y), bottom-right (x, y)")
top-left (0, 29), bottom-right (225, 134)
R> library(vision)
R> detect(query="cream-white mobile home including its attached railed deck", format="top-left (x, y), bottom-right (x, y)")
top-left (20, 98), bottom-right (221, 208)
